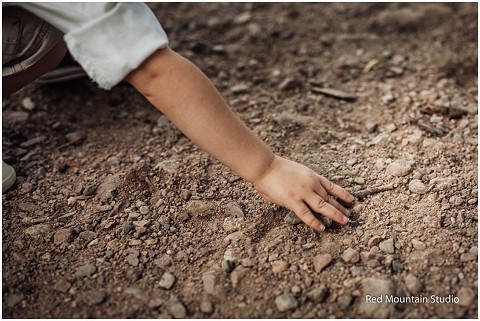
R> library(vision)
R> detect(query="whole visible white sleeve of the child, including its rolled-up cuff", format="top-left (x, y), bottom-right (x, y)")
top-left (16, 2), bottom-right (168, 89)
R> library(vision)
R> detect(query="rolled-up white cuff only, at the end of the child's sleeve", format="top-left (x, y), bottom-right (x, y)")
top-left (64, 3), bottom-right (168, 89)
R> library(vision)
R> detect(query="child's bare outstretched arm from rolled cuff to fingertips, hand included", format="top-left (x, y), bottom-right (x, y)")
top-left (127, 48), bottom-right (353, 231)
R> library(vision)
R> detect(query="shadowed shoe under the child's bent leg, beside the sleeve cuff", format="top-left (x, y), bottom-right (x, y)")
top-left (35, 52), bottom-right (88, 85)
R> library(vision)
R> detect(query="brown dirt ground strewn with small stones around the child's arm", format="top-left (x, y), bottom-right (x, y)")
top-left (2, 3), bottom-right (478, 318)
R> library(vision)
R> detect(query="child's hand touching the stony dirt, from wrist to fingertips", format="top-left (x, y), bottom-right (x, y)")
top-left (254, 156), bottom-right (354, 231)
